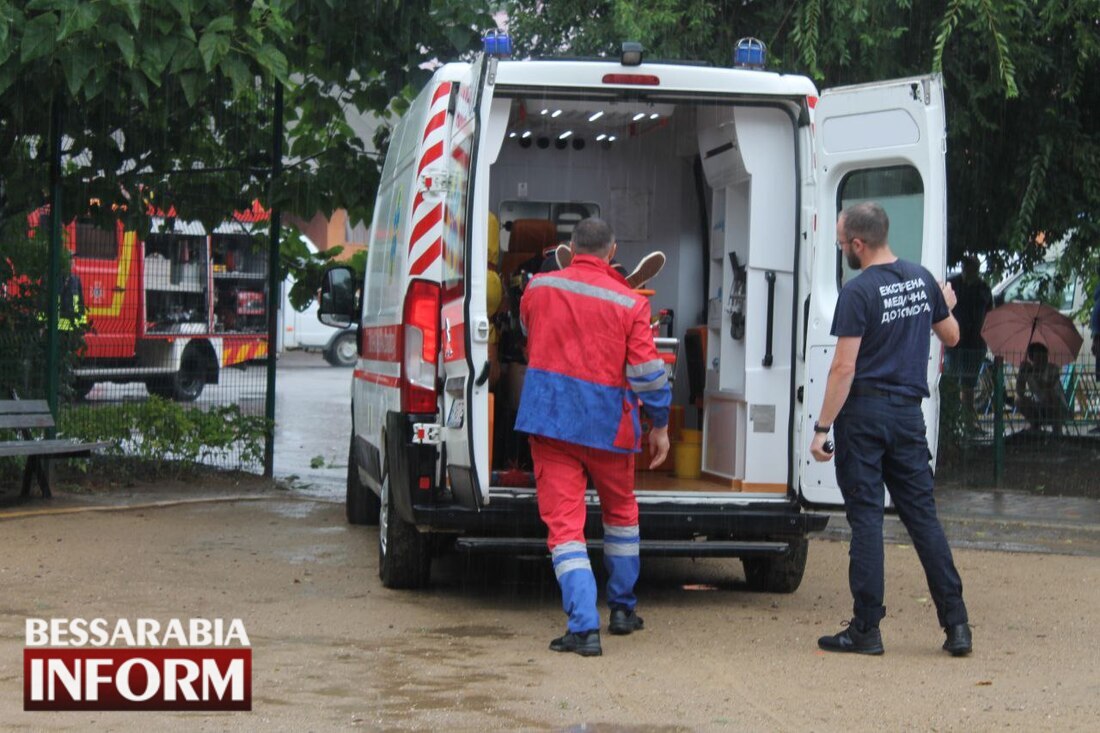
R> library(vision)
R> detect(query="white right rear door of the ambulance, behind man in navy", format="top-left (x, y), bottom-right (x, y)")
top-left (801, 75), bottom-right (947, 504)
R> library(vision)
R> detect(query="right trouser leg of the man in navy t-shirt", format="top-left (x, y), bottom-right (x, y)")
top-left (883, 411), bottom-right (968, 626)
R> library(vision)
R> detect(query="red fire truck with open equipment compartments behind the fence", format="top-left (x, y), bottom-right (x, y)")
top-left (37, 205), bottom-right (271, 402)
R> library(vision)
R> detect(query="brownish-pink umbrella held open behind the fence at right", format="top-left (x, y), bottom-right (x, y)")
top-left (981, 303), bottom-right (1082, 365)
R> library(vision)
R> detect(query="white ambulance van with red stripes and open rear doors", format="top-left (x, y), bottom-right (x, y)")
top-left (321, 38), bottom-right (946, 592)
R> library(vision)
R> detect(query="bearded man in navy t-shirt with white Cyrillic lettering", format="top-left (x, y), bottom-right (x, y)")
top-left (810, 203), bottom-right (972, 656)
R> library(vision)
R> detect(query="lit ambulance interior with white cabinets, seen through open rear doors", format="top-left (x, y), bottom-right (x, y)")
top-left (484, 87), bottom-right (801, 495)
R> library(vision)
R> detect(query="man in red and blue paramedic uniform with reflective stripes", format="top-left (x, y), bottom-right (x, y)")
top-left (516, 218), bottom-right (672, 656)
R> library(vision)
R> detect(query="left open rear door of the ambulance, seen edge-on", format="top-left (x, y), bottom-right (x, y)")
top-left (441, 54), bottom-right (496, 507)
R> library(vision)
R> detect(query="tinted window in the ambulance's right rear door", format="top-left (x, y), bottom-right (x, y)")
top-left (836, 165), bottom-right (924, 284)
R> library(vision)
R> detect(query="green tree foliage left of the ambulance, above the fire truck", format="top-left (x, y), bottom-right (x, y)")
top-left (0, 0), bottom-right (492, 239)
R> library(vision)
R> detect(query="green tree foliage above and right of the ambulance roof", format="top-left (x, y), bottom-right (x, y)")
top-left (507, 0), bottom-right (1100, 280)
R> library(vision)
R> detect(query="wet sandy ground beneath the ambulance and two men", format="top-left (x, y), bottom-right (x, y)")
top-left (0, 492), bottom-right (1100, 731)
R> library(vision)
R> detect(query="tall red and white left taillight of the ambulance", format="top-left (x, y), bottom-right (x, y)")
top-left (402, 280), bottom-right (440, 413)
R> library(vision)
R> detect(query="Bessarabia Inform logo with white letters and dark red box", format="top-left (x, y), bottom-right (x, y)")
top-left (23, 619), bottom-right (252, 711)
